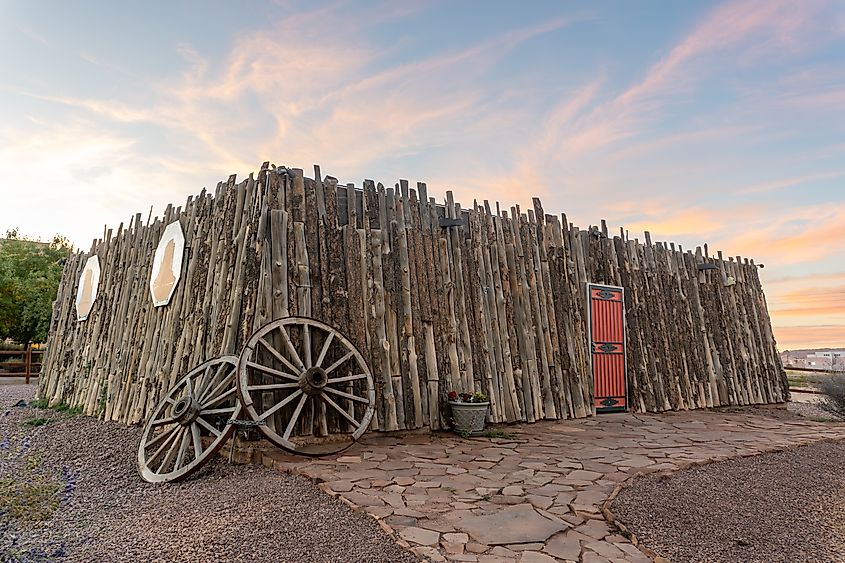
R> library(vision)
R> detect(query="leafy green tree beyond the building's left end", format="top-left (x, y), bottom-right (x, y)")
top-left (0, 229), bottom-right (72, 343)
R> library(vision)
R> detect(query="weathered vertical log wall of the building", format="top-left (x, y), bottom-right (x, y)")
top-left (39, 164), bottom-right (788, 430)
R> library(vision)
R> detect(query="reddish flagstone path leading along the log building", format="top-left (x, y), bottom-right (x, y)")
top-left (262, 406), bottom-right (845, 563)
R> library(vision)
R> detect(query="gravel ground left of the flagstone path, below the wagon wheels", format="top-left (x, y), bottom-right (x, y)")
top-left (0, 385), bottom-right (416, 563)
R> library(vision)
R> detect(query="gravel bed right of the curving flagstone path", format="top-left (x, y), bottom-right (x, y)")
top-left (611, 441), bottom-right (845, 563)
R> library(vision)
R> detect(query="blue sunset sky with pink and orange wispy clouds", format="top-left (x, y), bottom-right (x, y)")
top-left (0, 0), bottom-right (845, 350)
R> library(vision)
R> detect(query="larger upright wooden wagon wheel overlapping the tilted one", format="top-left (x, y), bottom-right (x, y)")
top-left (238, 317), bottom-right (375, 455)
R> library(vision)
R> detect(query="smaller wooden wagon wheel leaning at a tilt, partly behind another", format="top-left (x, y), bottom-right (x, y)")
top-left (138, 356), bottom-right (241, 483)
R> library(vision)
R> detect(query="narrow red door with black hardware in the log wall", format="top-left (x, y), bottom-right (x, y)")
top-left (587, 284), bottom-right (628, 412)
